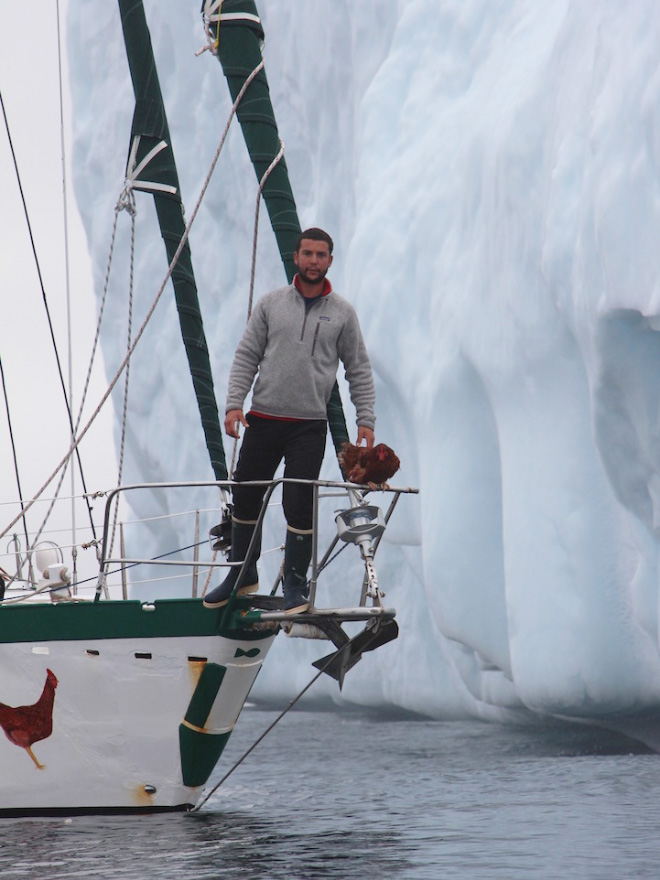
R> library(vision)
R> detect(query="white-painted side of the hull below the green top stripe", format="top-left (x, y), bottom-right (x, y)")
top-left (0, 633), bottom-right (274, 812)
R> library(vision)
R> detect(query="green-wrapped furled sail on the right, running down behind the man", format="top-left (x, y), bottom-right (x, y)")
top-left (211, 0), bottom-right (348, 451)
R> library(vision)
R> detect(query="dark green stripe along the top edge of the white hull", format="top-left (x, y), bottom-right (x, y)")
top-left (0, 599), bottom-right (274, 644)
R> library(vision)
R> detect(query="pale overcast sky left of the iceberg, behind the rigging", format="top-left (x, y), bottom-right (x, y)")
top-left (0, 0), bottom-right (117, 584)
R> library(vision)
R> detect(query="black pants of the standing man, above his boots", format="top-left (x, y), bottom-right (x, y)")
top-left (233, 414), bottom-right (328, 531)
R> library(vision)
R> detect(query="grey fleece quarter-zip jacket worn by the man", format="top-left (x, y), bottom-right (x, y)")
top-left (226, 284), bottom-right (375, 429)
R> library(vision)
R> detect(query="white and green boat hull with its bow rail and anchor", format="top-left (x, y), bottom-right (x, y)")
top-left (0, 481), bottom-right (412, 814)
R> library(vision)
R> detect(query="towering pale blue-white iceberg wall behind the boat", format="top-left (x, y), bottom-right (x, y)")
top-left (68, 0), bottom-right (660, 719)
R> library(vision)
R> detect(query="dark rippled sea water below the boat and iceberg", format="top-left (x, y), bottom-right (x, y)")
top-left (0, 708), bottom-right (660, 880)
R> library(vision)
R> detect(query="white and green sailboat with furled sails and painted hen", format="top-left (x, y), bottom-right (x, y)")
top-left (0, 0), bottom-right (416, 815)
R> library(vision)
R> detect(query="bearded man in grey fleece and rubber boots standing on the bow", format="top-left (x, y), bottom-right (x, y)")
top-left (204, 228), bottom-right (375, 614)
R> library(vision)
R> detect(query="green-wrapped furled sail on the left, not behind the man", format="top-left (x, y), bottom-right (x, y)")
top-left (118, 0), bottom-right (227, 480)
